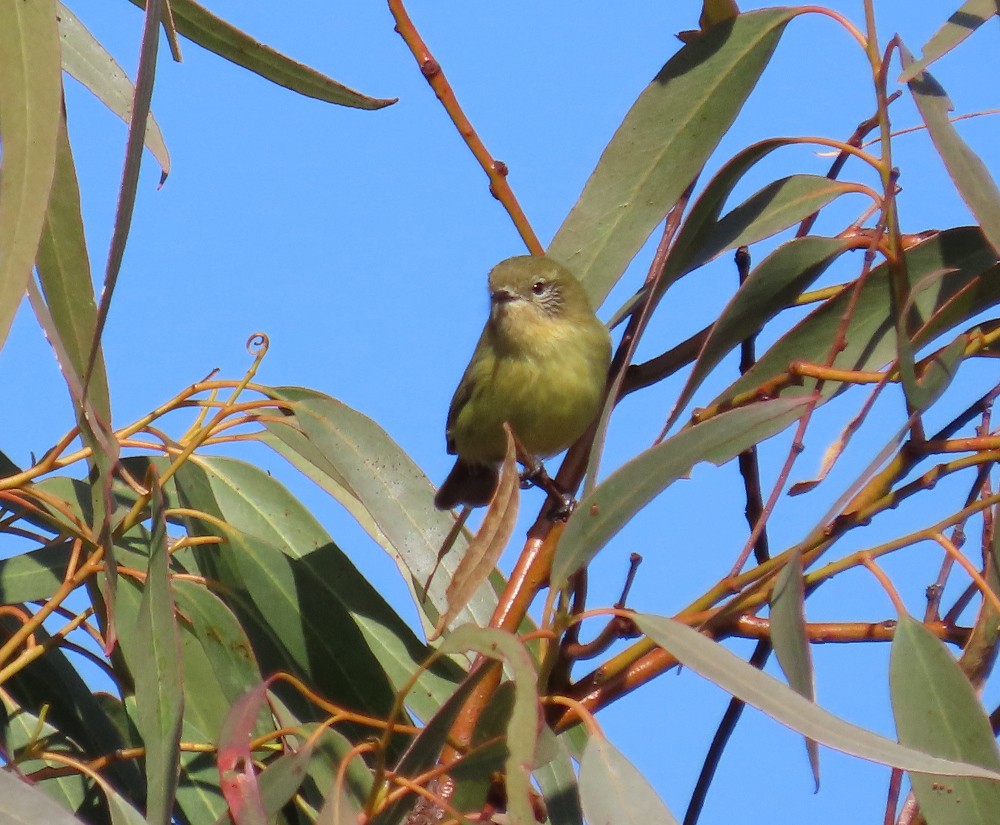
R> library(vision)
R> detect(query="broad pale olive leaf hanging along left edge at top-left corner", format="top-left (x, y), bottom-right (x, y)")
top-left (0, 0), bottom-right (62, 345)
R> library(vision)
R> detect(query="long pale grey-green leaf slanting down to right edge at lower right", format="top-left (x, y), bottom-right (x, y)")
top-left (634, 614), bottom-right (1000, 781)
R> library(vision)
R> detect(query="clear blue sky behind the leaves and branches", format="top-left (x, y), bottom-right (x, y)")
top-left (0, 0), bottom-right (1000, 825)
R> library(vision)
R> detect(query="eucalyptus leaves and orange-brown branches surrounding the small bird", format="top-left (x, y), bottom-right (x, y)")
top-left (0, 0), bottom-right (1000, 825)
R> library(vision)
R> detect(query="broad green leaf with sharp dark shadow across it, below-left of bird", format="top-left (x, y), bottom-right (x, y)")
top-left (165, 456), bottom-right (455, 718)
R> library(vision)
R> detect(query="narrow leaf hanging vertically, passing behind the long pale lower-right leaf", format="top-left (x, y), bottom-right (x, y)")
top-left (771, 550), bottom-right (819, 791)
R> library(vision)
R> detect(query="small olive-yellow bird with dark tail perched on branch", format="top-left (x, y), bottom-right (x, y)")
top-left (434, 255), bottom-right (611, 510)
